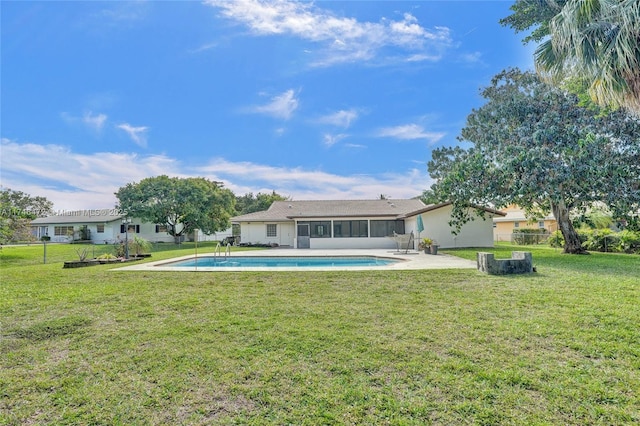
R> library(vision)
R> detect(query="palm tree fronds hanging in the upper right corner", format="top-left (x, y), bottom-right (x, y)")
top-left (535, 0), bottom-right (640, 116)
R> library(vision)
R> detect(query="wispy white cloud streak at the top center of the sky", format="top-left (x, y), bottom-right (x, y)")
top-left (205, 0), bottom-right (452, 66)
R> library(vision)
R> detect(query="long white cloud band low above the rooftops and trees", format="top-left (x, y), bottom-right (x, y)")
top-left (0, 138), bottom-right (431, 210)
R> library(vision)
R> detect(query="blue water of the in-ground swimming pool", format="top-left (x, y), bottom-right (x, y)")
top-left (158, 256), bottom-right (398, 268)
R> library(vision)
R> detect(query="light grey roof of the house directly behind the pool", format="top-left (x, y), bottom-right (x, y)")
top-left (231, 199), bottom-right (425, 223)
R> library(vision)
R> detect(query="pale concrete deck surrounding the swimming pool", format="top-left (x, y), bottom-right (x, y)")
top-left (112, 248), bottom-right (476, 272)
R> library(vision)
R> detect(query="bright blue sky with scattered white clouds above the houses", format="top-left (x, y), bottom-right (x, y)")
top-left (0, 0), bottom-right (534, 210)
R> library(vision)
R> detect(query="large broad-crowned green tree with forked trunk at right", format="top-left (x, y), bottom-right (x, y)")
top-left (428, 69), bottom-right (640, 253)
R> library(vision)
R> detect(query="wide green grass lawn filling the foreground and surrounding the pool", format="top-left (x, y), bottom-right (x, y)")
top-left (0, 241), bottom-right (640, 425)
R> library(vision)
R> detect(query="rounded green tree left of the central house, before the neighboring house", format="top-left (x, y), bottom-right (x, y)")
top-left (116, 175), bottom-right (235, 239)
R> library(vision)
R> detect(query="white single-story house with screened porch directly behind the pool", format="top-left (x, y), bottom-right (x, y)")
top-left (231, 199), bottom-right (502, 249)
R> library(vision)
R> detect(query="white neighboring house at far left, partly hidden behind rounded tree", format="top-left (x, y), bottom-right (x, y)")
top-left (31, 209), bottom-right (231, 244)
